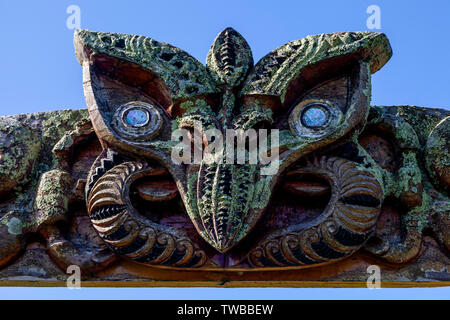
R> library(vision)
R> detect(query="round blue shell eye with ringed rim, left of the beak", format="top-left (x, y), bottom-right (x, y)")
top-left (111, 101), bottom-right (162, 141)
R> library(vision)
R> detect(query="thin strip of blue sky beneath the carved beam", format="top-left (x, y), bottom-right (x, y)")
top-left (0, 288), bottom-right (449, 300)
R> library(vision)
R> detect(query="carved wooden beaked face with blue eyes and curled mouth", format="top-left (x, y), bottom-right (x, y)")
top-left (75, 28), bottom-right (391, 267)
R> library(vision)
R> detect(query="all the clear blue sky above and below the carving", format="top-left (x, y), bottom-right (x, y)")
top-left (0, 0), bottom-right (450, 299)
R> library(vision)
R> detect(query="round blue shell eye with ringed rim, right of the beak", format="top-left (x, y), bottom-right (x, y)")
top-left (289, 100), bottom-right (342, 138)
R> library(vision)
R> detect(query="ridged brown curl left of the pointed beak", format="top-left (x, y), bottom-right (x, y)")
top-left (87, 162), bottom-right (207, 267)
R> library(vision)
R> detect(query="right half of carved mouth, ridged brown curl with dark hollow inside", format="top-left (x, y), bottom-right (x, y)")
top-left (249, 157), bottom-right (381, 267)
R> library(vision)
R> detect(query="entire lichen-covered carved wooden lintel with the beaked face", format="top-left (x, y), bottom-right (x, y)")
top-left (0, 28), bottom-right (450, 282)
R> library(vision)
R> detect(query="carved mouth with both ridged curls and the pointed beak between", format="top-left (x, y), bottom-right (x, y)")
top-left (88, 151), bottom-right (381, 268)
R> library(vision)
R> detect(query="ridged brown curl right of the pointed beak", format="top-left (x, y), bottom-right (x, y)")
top-left (248, 157), bottom-right (383, 267)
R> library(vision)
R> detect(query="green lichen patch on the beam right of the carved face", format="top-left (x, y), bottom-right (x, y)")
top-left (370, 106), bottom-right (450, 238)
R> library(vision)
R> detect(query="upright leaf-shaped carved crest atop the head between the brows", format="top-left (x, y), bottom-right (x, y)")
top-left (206, 28), bottom-right (253, 87)
